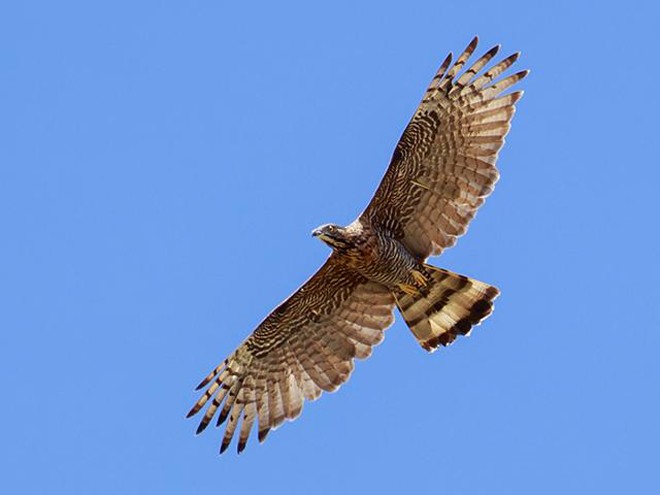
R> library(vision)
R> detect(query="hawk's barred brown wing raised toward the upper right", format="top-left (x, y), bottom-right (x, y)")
top-left (361, 37), bottom-right (528, 258)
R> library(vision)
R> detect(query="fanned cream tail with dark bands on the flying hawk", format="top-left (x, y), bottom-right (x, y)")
top-left (395, 265), bottom-right (500, 352)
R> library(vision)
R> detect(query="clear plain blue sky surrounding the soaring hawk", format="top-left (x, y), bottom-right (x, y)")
top-left (0, 1), bottom-right (660, 494)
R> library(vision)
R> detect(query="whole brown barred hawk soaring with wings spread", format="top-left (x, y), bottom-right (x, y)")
top-left (188, 37), bottom-right (528, 453)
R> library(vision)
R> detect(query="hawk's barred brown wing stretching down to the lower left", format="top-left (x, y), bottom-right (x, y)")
top-left (188, 255), bottom-right (394, 453)
